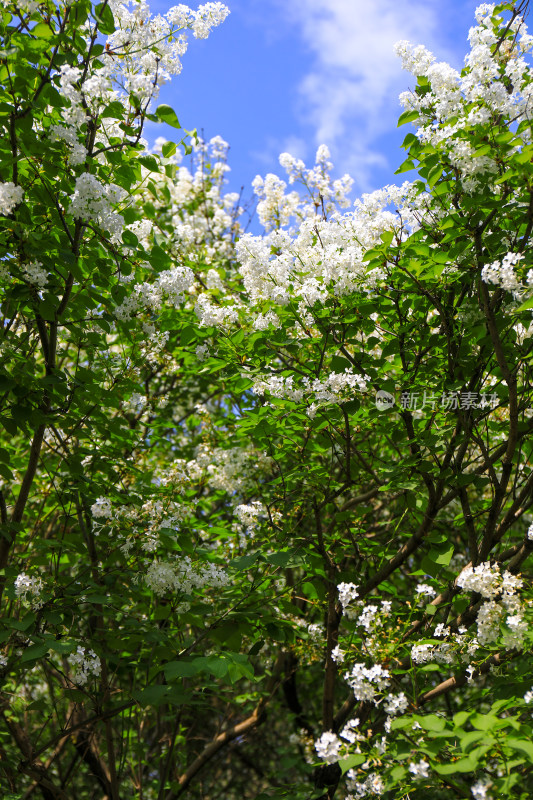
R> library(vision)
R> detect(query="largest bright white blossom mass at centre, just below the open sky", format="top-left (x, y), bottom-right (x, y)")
top-left (236, 183), bottom-right (427, 316)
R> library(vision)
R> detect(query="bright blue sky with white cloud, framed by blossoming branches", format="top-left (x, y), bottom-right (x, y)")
top-left (147, 0), bottom-right (478, 203)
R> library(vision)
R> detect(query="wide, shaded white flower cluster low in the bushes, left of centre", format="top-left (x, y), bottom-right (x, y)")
top-left (145, 556), bottom-right (229, 597)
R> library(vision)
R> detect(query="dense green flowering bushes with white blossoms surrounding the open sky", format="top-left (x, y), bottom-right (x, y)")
top-left (0, 0), bottom-right (533, 800)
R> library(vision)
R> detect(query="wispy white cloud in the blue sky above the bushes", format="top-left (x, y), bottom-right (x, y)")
top-left (281, 0), bottom-right (460, 189)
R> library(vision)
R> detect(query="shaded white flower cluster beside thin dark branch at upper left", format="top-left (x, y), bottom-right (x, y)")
top-left (70, 172), bottom-right (125, 239)
